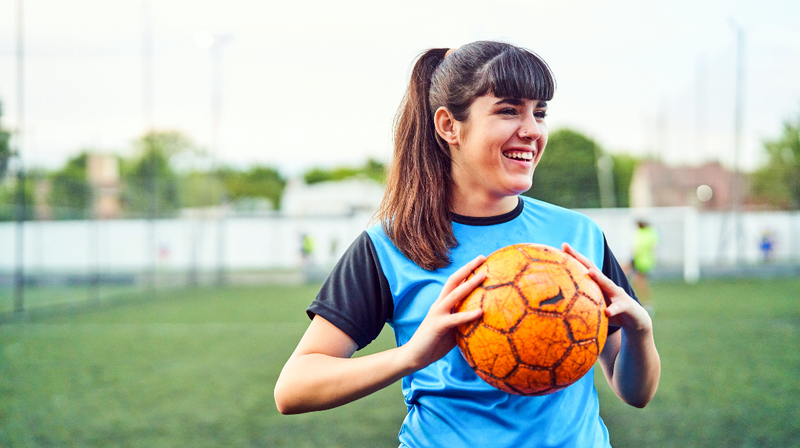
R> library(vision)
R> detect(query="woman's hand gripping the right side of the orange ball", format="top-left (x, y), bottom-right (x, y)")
top-left (561, 243), bottom-right (653, 332)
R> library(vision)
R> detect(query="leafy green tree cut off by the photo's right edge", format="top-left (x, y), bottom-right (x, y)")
top-left (750, 114), bottom-right (800, 210)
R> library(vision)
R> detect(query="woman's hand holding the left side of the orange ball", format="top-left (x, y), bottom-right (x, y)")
top-left (400, 255), bottom-right (486, 370)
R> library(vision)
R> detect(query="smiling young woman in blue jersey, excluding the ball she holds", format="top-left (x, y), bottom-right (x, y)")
top-left (275, 42), bottom-right (661, 447)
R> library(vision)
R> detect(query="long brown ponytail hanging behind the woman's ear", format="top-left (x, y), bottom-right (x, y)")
top-left (376, 48), bottom-right (458, 270)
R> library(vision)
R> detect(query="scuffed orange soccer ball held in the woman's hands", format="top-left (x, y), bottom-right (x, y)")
top-left (456, 244), bottom-right (608, 395)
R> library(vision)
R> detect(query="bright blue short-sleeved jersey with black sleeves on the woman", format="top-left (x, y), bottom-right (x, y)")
top-left (309, 197), bottom-right (633, 447)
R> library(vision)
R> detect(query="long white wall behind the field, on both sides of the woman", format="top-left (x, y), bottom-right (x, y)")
top-left (0, 207), bottom-right (800, 278)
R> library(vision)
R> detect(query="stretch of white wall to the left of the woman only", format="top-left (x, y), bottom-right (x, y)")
top-left (0, 213), bottom-right (371, 272)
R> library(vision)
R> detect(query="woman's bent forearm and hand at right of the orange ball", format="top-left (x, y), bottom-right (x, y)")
top-left (562, 243), bottom-right (661, 408)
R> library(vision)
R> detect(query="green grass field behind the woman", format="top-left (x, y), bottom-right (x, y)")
top-left (0, 279), bottom-right (800, 448)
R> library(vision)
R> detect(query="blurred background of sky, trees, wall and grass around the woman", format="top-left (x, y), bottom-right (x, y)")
top-left (0, 0), bottom-right (800, 447)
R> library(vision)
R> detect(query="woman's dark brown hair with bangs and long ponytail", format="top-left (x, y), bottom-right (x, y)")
top-left (376, 41), bottom-right (555, 270)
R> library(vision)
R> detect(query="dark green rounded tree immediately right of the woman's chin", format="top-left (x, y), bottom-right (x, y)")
top-left (524, 129), bottom-right (602, 208)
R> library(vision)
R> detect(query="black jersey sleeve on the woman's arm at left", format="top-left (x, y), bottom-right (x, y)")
top-left (306, 232), bottom-right (394, 350)
